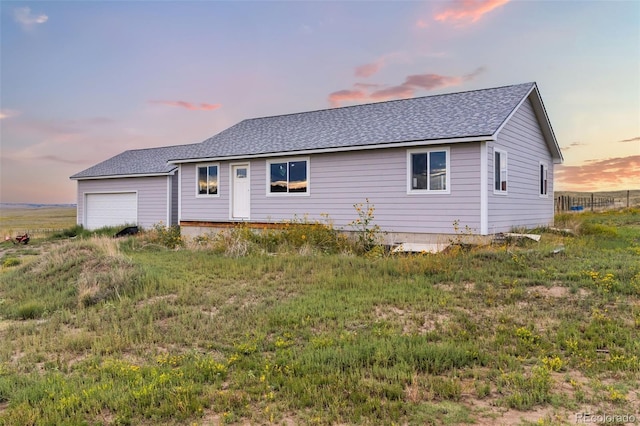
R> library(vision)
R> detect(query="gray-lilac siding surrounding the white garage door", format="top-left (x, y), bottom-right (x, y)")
top-left (78, 176), bottom-right (169, 229)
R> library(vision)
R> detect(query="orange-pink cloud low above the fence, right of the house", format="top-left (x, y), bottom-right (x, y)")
top-left (555, 155), bottom-right (640, 191)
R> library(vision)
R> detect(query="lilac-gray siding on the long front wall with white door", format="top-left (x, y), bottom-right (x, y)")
top-left (181, 143), bottom-right (480, 233)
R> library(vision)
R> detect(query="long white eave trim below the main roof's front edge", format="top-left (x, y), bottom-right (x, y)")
top-left (168, 135), bottom-right (496, 164)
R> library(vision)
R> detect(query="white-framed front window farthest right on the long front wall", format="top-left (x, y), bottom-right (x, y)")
top-left (409, 149), bottom-right (449, 193)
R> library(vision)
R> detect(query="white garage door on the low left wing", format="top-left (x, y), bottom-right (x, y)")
top-left (85, 192), bottom-right (138, 229)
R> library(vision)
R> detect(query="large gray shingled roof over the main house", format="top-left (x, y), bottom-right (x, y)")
top-left (172, 83), bottom-right (559, 163)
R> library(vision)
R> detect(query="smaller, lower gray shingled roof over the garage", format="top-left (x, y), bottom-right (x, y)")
top-left (71, 145), bottom-right (195, 179)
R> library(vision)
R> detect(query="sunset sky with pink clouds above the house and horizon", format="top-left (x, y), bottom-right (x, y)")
top-left (0, 0), bottom-right (640, 203)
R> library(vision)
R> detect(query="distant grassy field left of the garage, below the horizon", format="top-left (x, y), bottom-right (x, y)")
top-left (0, 206), bottom-right (76, 237)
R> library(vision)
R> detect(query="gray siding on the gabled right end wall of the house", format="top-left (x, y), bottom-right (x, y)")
top-left (487, 99), bottom-right (554, 234)
